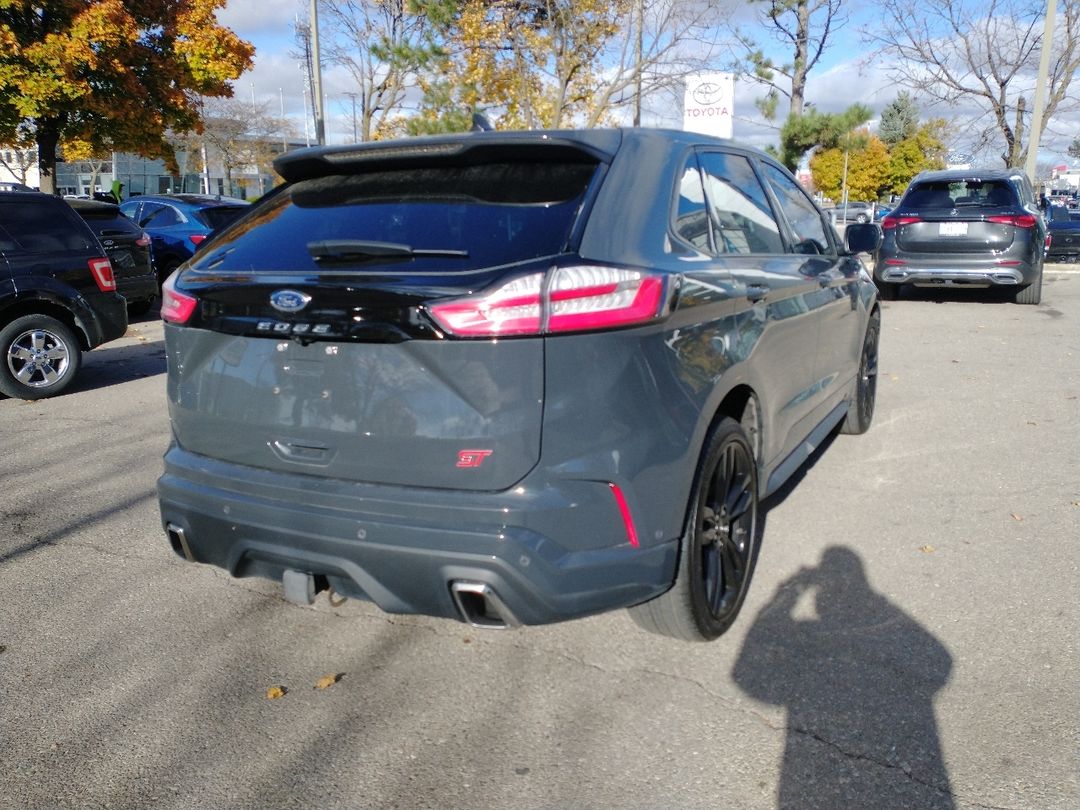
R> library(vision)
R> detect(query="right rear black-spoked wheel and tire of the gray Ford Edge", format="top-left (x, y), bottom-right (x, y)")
top-left (630, 417), bottom-right (758, 642)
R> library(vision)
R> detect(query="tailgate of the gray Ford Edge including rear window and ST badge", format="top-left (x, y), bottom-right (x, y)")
top-left (166, 139), bottom-right (613, 490)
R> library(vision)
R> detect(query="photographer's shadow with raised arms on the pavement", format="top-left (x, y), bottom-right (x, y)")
top-left (733, 546), bottom-right (955, 810)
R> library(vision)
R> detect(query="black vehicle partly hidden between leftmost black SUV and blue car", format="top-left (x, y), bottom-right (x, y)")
top-left (67, 200), bottom-right (158, 315)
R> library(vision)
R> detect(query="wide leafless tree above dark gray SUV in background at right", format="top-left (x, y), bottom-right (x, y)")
top-left (865, 0), bottom-right (1080, 166)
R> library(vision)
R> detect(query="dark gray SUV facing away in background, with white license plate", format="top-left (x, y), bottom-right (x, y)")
top-left (874, 168), bottom-right (1048, 303)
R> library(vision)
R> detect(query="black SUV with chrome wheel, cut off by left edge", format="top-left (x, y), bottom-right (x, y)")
top-left (0, 191), bottom-right (127, 400)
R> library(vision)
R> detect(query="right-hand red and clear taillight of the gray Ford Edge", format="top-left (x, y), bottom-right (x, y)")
top-left (429, 266), bottom-right (664, 337)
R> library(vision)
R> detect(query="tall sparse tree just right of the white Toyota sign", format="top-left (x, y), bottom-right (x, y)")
top-left (737, 0), bottom-right (848, 119)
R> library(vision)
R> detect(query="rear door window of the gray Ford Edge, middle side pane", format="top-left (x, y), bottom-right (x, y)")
top-left (700, 152), bottom-right (784, 254)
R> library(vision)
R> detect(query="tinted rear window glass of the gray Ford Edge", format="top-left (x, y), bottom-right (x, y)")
top-left (197, 162), bottom-right (596, 273)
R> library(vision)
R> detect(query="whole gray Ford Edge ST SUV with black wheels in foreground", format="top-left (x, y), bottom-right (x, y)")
top-left (158, 130), bottom-right (880, 639)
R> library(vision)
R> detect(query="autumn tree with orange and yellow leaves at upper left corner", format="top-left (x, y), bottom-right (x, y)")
top-left (0, 0), bottom-right (254, 192)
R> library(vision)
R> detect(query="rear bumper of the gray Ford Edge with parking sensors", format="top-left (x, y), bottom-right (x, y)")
top-left (158, 446), bottom-right (677, 624)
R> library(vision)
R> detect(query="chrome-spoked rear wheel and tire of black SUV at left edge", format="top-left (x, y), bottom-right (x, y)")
top-left (0, 314), bottom-right (82, 400)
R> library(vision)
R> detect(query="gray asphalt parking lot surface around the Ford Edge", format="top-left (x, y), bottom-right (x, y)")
top-left (0, 266), bottom-right (1080, 810)
